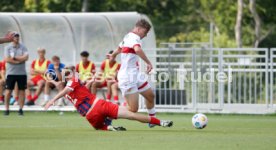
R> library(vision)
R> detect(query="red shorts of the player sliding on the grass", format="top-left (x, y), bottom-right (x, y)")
top-left (86, 100), bottom-right (119, 129)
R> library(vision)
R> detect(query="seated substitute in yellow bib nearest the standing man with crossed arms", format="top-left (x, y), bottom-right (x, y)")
top-left (26, 48), bottom-right (50, 106)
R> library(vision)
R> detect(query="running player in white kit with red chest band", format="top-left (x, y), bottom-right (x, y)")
top-left (110, 19), bottom-right (156, 127)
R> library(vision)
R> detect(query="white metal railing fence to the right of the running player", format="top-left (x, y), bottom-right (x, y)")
top-left (140, 44), bottom-right (276, 114)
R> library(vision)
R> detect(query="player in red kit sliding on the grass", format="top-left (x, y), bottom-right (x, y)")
top-left (45, 66), bottom-right (173, 131)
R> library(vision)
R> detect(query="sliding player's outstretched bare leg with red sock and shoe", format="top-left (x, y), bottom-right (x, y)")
top-left (118, 106), bottom-right (173, 127)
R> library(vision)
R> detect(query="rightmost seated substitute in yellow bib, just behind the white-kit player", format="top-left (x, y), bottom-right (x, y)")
top-left (91, 51), bottom-right (120, 104)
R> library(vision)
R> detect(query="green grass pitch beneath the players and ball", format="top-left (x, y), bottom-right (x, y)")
top-left (0, 112), bottom-right (276, 150)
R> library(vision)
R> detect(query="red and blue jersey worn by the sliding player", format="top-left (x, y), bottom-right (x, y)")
top-left (65, 78), bottom-right (96, 116)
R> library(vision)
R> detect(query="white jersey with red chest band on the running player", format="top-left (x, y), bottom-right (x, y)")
top-left (119, 32), bottom-right (142, 71)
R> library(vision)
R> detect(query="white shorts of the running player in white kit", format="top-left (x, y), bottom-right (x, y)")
top-left (118, 71), bottom-right (151, 96)
